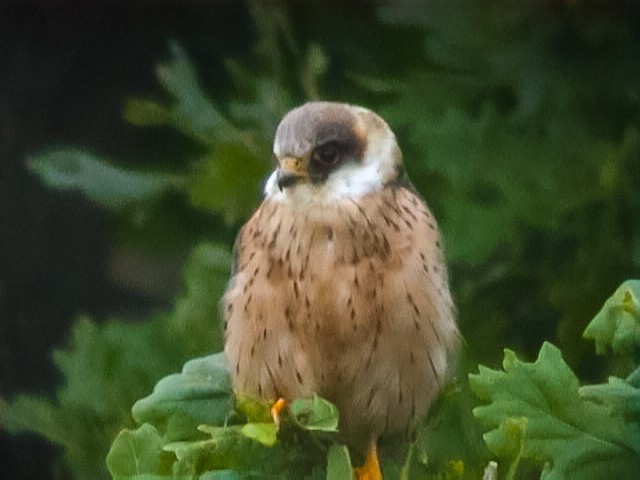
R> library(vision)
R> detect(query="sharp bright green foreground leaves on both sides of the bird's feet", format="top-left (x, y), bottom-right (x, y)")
top-left (100, 280), bottom-right (640, 480)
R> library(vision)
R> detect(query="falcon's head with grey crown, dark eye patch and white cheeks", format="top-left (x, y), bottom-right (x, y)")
top-left (265, 102), bottom-right (402, 205)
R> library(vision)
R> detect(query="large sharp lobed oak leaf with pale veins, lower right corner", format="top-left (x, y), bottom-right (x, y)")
top-left (469, 343), bottom-right (640, 479)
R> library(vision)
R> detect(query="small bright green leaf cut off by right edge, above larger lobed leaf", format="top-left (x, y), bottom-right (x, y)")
top-left (584, 280), bottom-right (640, 354)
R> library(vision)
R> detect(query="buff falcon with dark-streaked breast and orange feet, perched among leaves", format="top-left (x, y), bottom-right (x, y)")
top-left (221, 101), bottom-right (459, 480)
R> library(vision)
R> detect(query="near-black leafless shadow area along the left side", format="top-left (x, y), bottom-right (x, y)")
top-left (0, 1), bottom-right (253, 478)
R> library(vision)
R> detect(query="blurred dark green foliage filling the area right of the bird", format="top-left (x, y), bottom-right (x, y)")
top-left (355, 2), bottom-right (640, 368)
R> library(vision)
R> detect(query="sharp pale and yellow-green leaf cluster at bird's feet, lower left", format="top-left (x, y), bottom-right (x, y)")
top-left (107, 354), bottom-right (338, 478)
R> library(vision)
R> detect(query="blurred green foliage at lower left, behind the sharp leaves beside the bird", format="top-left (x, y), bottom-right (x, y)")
top-left (0, 244), bottom-right (230, 478)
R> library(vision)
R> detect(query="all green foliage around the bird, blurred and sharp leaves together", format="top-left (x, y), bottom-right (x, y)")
top-left (0, 2), bottom-right (640, 479)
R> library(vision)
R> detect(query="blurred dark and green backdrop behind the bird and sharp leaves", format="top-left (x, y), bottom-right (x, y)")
top-left (0, 0), bottom-right (640, 478)
